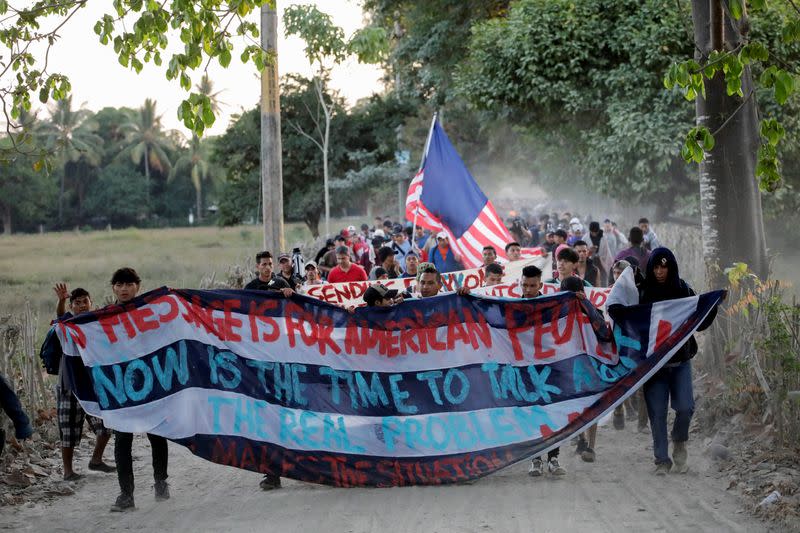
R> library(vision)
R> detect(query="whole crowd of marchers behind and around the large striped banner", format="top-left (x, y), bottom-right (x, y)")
top-left (0, 213), bottom-right (714, 511)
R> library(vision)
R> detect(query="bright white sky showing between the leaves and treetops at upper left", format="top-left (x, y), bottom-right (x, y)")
top-left (34, 0), bottom-right (383, 135)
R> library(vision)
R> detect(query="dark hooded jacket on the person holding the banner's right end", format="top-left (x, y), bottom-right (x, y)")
top-left (639, 247), bottom-right (717, 364)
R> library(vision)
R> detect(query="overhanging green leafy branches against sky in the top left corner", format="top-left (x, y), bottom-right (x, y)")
top-left (0, 0), bottom-right (272, 149)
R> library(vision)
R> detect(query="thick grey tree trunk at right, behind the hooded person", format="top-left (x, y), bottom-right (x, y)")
top-left (692, 0), bottom-right (768, 287)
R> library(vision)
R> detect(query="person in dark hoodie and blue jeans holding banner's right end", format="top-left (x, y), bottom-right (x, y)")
top-left (639, 248), bottom-right (717, 476)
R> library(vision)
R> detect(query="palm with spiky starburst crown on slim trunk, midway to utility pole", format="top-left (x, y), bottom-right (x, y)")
top-left (120, 98), bottom-right (172, 208)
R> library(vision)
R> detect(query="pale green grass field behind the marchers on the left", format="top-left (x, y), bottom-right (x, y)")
top-left (0, 220), bottom-right (318, 332)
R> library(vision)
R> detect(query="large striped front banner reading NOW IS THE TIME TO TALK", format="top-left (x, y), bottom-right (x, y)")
top-left (57, 288), bottom-right (724, 487)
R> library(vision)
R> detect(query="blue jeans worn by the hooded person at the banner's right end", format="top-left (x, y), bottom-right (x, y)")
top-left (642, 361), bottom-right (694, 465)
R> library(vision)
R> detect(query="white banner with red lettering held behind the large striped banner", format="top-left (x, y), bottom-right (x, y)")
top-left (301, 256), bottom-right (552, 307)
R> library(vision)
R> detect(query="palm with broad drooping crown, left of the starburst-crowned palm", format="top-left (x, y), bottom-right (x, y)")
top-left (46, 96), bottom-right (103, 222)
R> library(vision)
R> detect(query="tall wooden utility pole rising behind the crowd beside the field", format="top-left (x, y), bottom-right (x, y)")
top-left (261, 0), bottom-right (284, 254)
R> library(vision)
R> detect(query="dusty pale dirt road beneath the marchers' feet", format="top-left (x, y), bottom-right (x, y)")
top-left (0, 420), bottom-right (768, 533)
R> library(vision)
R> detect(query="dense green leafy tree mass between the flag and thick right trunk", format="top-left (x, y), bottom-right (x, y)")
top-left (455, 0), bottom-right (696, 212)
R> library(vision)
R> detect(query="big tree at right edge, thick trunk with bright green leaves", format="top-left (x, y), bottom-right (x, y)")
top-left (664, 0), bottom-right (800, 283)
